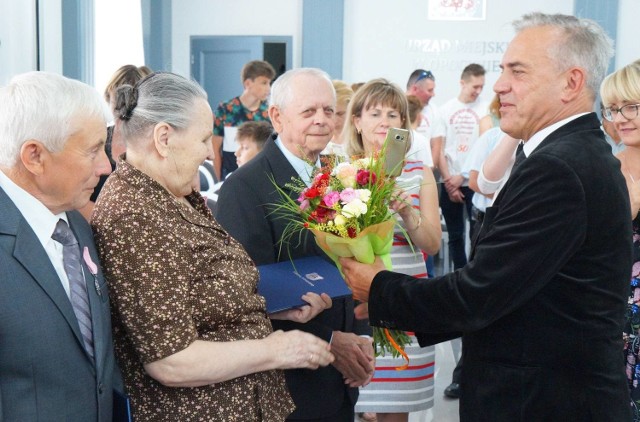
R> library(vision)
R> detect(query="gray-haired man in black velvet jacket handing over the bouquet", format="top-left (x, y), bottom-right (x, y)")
top-left (343, 13), bottom-right (631, 421)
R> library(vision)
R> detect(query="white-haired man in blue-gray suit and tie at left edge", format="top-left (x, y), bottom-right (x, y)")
top-left (0, 72), bottom-right (122, 422)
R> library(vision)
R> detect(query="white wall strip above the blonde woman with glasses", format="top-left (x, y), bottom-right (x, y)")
top-left (616, 0), bottom-right (640, 69)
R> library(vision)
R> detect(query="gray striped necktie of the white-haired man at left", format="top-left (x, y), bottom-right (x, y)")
top-left (51, 219), bottom-right (94, 358)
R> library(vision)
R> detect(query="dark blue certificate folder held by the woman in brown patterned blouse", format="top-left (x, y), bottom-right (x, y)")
top-left (258, 256), bottom-right (351, 314)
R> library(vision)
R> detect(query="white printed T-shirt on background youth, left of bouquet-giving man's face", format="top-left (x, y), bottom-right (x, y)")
top-left (440, 98), bottom-right (488, 175)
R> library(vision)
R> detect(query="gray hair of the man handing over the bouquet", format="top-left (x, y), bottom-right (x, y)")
top-left (513, 13), bottom-right (614, 98)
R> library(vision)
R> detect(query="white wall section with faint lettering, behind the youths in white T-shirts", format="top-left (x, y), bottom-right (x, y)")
top-left (343, 0), bottom-right (572, 105)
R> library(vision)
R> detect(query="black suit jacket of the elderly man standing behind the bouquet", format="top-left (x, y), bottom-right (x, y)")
top-left (216, 138), bottom-right (358, 418)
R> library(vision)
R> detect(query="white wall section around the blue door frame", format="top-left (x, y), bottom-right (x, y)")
top-left (171, 0), bottom-right (304, 77)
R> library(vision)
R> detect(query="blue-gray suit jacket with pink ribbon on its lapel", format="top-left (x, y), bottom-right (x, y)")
top-left (0, 189), bottom-right (122, 422)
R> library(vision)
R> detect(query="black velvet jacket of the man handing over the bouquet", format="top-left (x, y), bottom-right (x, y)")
top-left (369, 113), bottom-right (632, 422)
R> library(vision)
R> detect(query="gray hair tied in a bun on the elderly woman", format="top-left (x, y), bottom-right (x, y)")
top-left (114, 72), bottom-right (206, 142)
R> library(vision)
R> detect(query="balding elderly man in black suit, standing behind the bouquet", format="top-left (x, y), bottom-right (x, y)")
top-left (216, 68), bottom-right (374, 421)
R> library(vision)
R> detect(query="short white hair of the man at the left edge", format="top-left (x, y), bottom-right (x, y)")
top-left (0, 72), bottom-right (111, 167)
